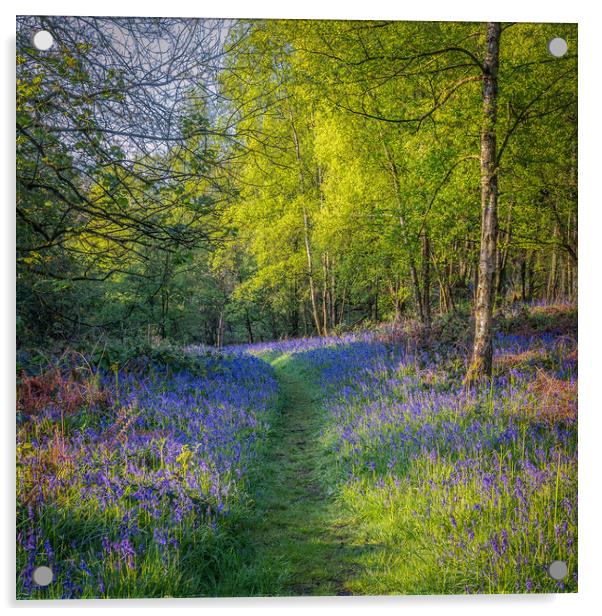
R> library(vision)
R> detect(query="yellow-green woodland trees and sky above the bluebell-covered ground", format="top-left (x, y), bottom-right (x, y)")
top-left (17, 17), bottom-right (577, 372)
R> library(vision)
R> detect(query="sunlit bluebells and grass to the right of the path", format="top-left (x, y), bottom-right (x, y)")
top-left (268, 306), bottom-right (577, 594)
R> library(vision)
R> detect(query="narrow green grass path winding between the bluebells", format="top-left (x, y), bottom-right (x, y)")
top-left (233, 356), bottom-right (357, 595)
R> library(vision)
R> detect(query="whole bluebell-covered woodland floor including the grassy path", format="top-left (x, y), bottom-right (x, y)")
top-left (17, 306), bottom-right (577, 598)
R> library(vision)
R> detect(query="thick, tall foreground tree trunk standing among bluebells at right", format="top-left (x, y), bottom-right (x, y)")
top-left (466, 22), bottom-right (501, 384)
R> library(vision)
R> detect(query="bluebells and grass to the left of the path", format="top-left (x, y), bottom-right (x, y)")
top-left (17, 355), bottom-right (276, 598)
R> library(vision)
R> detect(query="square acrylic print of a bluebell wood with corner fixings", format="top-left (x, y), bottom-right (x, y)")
top-left (16, 16), bottom-right (577, 599)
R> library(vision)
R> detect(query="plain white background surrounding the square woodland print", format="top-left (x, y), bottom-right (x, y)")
top-left (0, 0), bottom-right (602, 616)
